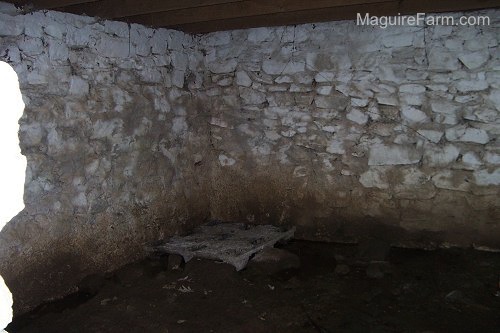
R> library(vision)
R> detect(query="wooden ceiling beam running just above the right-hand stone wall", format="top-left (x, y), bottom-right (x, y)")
top-left (127, 0), bottom-right (499, 33)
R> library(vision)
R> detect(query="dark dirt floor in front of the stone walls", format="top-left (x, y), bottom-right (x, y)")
top-left (8, 241), bottom-right (500, 333)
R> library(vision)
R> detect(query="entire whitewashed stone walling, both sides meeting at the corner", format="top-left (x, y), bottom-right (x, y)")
top-left (0, 3), bottom-right (500, 313)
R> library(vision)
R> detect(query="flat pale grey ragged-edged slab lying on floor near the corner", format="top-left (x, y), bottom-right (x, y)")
top-left (150, 223), bottom-right (295, 271)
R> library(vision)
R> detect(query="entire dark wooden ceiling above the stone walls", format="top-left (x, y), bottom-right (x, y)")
top-left (7, 0), bottom-right (500, 33)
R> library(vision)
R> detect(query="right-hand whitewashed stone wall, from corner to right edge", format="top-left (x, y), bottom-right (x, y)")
top-left (200, 10), bottom-right (500, 248)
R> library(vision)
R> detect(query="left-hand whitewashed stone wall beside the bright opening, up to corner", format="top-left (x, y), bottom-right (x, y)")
top-left (0, 4), bottom-right (209, 313)
